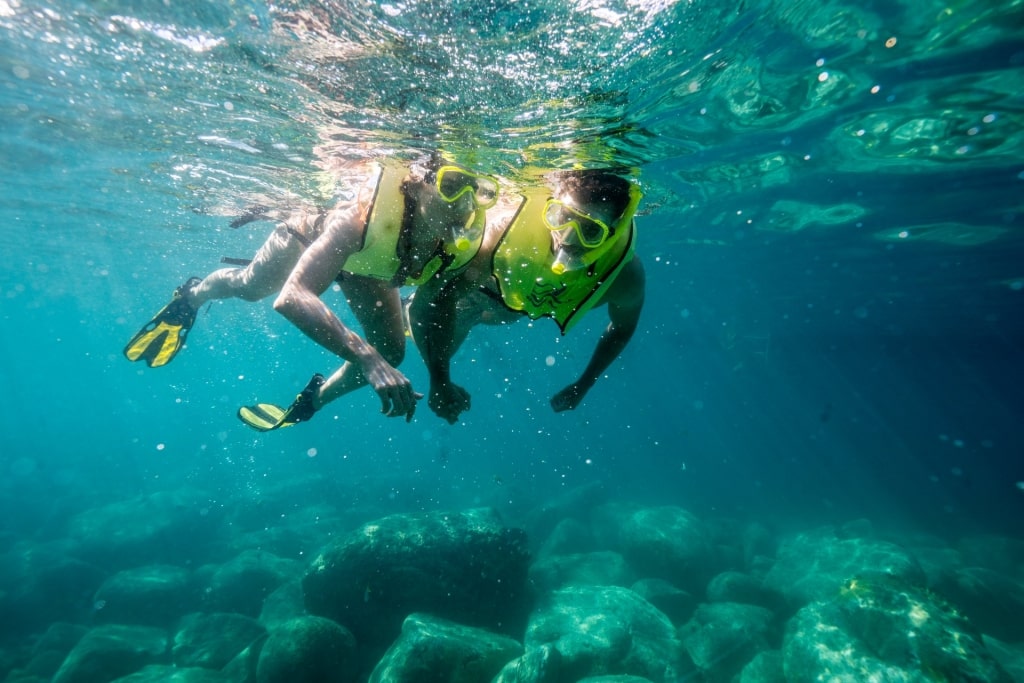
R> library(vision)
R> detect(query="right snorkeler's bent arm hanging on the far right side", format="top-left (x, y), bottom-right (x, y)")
top-left (551, 258), bottom-right (646, 413)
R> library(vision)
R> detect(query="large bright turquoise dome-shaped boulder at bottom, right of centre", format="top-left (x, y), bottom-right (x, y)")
top-left (512, 586), bottom-right (689, 683)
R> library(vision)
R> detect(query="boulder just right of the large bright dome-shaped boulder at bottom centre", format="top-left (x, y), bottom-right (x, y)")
top-left (679, 602), bottom-right (780, 683)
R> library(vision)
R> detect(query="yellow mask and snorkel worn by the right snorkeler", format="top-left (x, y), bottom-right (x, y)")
top-left (543, 184), bottom-right (643, 275)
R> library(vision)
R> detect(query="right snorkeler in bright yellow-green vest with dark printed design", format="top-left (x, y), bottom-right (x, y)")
top-left (239, 171), bottom-right (644, 430)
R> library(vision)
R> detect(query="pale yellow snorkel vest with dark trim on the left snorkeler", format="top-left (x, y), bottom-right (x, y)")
top-left (343, 163), bottom-right (483, 285)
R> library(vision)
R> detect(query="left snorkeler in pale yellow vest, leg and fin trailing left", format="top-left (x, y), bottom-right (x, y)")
top-left (124, 157), bottom-right (498, 424)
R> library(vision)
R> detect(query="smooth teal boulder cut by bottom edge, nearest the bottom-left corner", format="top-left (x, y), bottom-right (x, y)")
top-left (53, 624), bottom-right (167, 683)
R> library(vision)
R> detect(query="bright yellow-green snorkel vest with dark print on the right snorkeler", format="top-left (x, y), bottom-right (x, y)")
top-left (492, 188), bottom-right (636, 334)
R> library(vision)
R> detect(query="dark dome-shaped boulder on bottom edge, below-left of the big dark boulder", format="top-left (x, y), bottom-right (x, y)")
top-left (256, 616), bottom-right (357, 683)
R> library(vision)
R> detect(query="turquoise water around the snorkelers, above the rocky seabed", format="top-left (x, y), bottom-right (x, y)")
top-left (0, 0), bottom-right (1024, 679)
